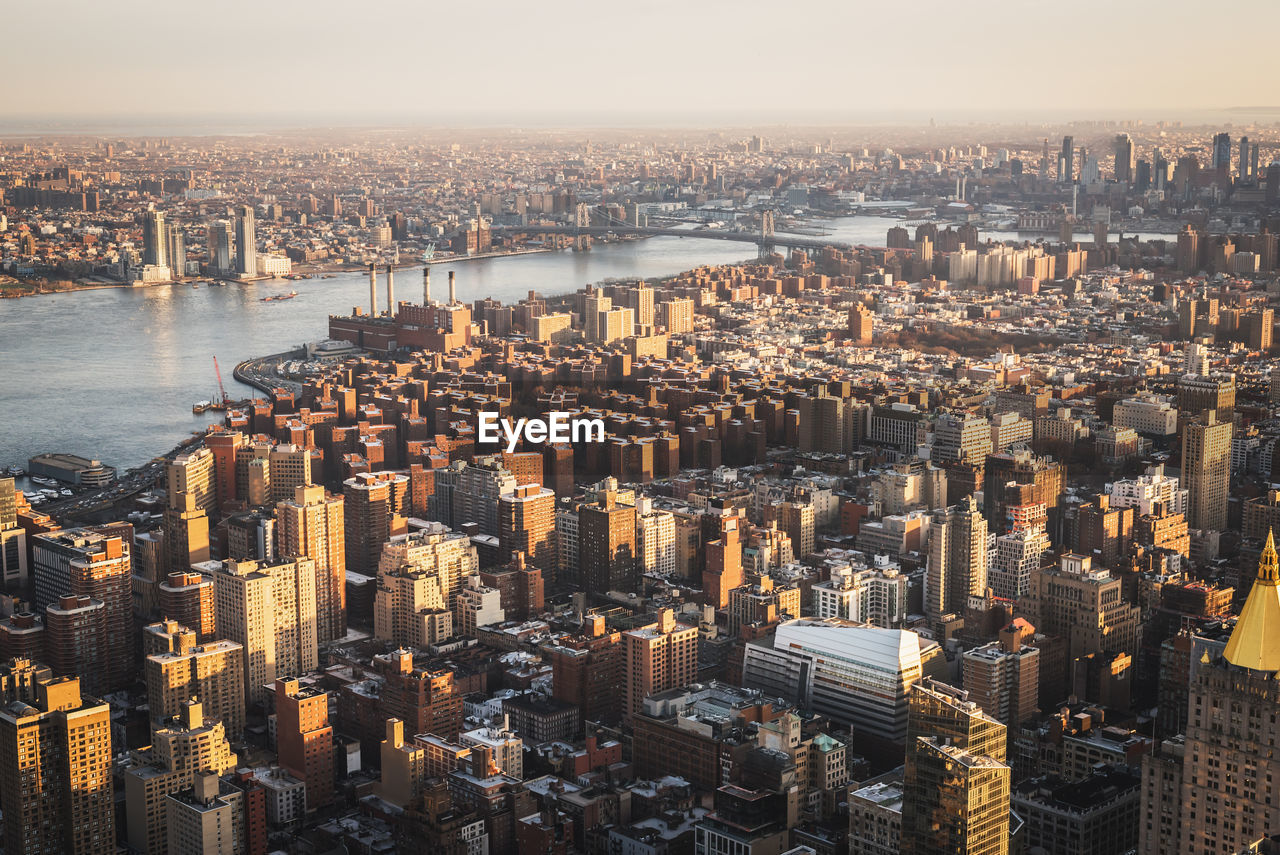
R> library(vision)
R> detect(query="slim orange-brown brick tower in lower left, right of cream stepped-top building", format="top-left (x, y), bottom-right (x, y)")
top-left (275, 677), bottom-right (334, 810)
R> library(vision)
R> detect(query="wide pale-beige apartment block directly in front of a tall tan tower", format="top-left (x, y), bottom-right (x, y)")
top-left (208, 558), bottom-right (319, 704)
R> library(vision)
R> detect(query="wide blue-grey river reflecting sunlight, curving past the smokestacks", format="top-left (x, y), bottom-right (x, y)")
top-left (0, 216), bottom-right (1172, 470)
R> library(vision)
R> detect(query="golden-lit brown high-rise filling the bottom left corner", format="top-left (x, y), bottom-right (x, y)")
top-left (0, 659), bottom-right (115, 855)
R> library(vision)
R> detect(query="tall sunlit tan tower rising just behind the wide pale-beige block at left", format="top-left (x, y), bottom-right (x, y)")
top-left (275, 486), bottom-right (347, 644)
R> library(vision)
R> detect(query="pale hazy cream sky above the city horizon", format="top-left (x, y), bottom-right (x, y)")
top-left (10, 0), bottom-right (1280, 124)
